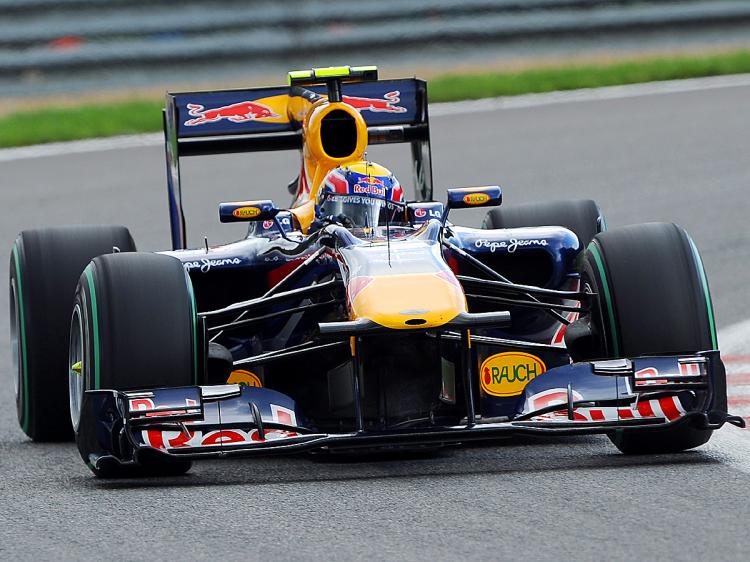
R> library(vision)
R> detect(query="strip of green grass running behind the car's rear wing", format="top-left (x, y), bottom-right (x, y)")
top-left (0, 50), bottom-right (750, 147)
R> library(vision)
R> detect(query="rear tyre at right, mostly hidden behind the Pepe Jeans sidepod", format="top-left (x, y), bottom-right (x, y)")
top-left (482, 199), bottom-right (607, 248)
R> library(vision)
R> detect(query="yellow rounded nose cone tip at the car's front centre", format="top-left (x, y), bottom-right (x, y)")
top-left (349, 271), bottom-right (466, 330)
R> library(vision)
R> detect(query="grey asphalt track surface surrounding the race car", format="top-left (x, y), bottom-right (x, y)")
top-left (0, 82), bottom-right (750, 561)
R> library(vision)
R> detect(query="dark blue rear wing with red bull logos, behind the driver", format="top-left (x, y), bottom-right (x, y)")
top-left (164, 78), bottom-right (432, 250)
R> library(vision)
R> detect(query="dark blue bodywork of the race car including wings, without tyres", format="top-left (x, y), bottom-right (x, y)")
top-left (77, 70), bottom-right (740, 468)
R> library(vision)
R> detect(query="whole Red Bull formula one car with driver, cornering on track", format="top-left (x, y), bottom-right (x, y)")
top-left (10, 67), bottom-right (744, 476)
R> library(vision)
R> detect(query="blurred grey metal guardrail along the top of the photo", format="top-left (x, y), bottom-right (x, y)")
top-left (0, 0), bottom-right (750, 78)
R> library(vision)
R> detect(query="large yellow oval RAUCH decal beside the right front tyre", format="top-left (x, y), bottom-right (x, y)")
top-left (479, 351), bottom-right (547, 396)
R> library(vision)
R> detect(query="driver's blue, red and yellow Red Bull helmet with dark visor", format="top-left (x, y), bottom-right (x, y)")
top-left (317, 160), bottom-right (407, 228)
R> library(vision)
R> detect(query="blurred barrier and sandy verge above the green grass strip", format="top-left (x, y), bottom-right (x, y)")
top-left (0, 0), bottom-right (750, 102)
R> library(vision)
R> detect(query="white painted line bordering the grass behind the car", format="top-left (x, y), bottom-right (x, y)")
top-left (0, 74), bottom-right (750, 162)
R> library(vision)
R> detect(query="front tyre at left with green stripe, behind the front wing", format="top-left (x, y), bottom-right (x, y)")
top-left (69, 253), bottom-right (198, 477)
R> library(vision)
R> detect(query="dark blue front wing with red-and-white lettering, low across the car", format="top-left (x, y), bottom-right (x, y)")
top-left (77, 351), bottom-right (744, 468)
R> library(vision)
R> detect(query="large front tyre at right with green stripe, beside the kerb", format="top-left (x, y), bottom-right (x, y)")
top-left (583, 223), bottom-right (726, 454)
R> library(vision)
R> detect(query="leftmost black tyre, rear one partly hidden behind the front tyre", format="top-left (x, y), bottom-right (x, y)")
top-left (10, 226), bottom-right (135, 441)
